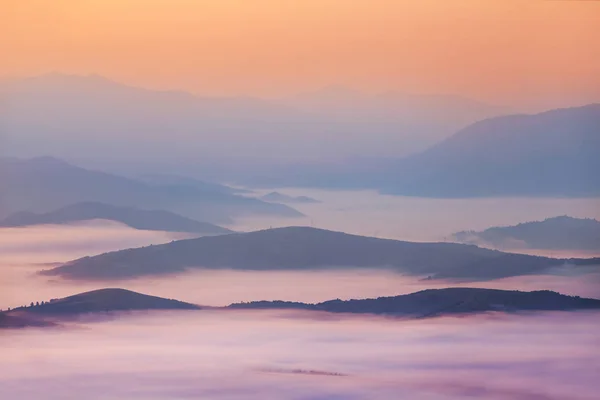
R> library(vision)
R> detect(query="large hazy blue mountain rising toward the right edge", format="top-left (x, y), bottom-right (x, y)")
top-left (198, 104), bottom-right (600, 193)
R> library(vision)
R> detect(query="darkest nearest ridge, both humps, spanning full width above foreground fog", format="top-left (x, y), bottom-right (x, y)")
top-left (0, 288), bottom-right (600, 328)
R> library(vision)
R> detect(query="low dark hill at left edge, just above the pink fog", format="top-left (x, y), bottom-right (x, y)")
top-left (0, 202), bottom-right (232, 235)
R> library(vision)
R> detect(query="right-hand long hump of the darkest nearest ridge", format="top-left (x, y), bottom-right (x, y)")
top-left (229, 288), bottom-right (600, 317)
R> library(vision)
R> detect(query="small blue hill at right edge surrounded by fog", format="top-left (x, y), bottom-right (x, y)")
top-left (452, 216), bottom-right (600, 251)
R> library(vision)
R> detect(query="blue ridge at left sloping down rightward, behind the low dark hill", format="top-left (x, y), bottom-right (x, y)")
top-left (0, 157), bottom-right (302, 223)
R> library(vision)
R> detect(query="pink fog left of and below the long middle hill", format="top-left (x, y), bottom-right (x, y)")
top-left (0, 208), bottom-right (600, 309)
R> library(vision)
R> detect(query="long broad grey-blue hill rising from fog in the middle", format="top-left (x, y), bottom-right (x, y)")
top-left (43, 227), bottom-right (600, 280)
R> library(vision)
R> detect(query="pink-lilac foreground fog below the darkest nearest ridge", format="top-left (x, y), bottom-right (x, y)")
top-left (0, 311), bottom-right (600, 400)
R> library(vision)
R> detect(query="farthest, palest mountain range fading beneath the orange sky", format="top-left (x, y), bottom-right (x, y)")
top-left (0, 74), bottom-right (504, 173)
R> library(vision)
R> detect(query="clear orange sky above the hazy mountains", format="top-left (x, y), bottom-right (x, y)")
top-left (0, 0), bottom-right (600, 105)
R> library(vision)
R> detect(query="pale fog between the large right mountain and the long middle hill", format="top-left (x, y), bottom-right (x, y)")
top-left (230, 188), bottom-right (600, 247)
